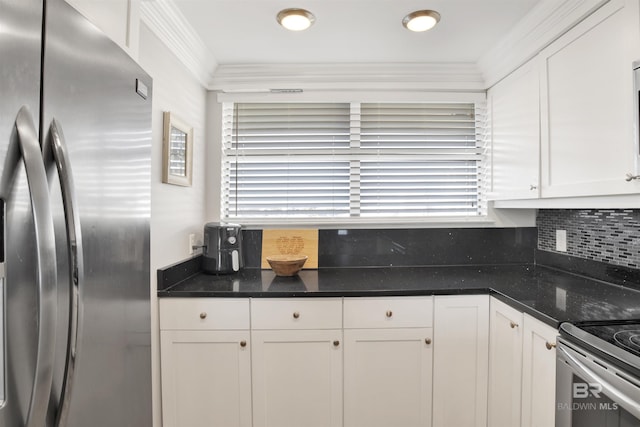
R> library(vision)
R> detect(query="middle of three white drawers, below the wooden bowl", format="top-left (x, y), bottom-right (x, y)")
top-left (251, 298), bottom-right (342, 329)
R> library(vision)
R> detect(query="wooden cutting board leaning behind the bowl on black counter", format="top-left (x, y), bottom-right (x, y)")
top-left (262, 229), bottom-right (318, 269)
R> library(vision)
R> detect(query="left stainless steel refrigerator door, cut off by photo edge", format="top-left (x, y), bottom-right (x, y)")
top-left (0, 0), bottom-right (55, 427)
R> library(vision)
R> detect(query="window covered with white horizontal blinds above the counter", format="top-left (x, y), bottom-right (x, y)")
top-left (222, 103), bottom-right (485, 222)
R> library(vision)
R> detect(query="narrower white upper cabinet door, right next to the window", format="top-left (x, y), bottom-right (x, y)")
top-left (488, 60), bottom-right (540, 200)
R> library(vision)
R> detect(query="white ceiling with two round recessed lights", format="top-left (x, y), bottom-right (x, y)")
top-left (174, 0), bottom-right (541, 65)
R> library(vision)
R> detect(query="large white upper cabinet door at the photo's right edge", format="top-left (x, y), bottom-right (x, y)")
top-left (540, 0), bottom-right (640, 197)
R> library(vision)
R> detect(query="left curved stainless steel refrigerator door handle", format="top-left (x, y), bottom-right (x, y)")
top-left (0, 107), bottom-right (58, 427)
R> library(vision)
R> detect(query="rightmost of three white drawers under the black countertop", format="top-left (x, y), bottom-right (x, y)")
top-left (344, 296), bottom-right (433, 329)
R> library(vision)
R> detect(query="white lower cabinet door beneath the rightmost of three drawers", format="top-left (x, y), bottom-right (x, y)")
top-left (344, 328), bottom-right (432, 427)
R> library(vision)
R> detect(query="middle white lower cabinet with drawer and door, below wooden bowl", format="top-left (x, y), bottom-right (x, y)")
top-left (251, 298), bottom-right (343, 427)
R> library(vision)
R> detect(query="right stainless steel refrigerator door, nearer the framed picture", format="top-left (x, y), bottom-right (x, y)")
top-left (42, 0), bottom-right (152, 427)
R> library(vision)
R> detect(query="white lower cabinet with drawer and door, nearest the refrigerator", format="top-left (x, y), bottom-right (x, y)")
top-left (160, 298), bottom-right (252, 427)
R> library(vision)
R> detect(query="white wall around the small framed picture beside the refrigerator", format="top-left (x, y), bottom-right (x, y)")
top-left (139, 23), bottom-right (207, 427)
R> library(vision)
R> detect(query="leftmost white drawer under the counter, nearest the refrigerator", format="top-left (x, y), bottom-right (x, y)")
top-left (160, 298), bottom-right (250, 330)
